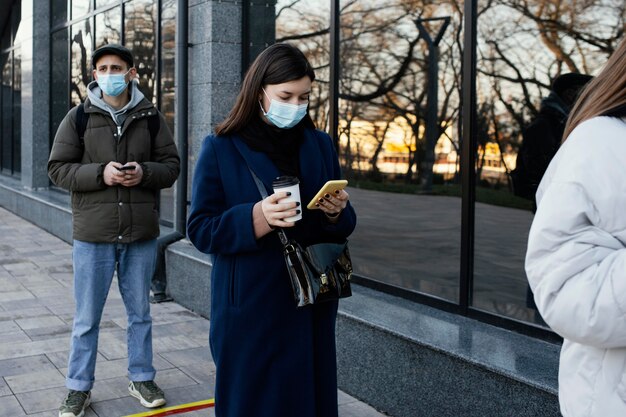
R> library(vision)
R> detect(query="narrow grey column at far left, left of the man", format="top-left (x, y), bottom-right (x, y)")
top-left (20, 0), bottom-right (51, 189)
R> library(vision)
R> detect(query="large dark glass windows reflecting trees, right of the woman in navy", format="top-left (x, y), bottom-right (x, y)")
top-left (268, 0), bottom-right (625, 333)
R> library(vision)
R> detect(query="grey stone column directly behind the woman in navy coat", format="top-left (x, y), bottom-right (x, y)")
top-left (183, 0), bottom-right (276, 172)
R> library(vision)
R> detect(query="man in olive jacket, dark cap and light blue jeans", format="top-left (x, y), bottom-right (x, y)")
top-left (48, 44), bottom-right (180, 417)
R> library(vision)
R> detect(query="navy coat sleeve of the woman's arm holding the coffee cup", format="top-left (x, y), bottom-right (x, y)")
top-left (187, 136), bottom-right (260, 254)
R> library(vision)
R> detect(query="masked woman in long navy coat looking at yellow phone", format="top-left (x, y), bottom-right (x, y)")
top-left (187, 44), bottom-right (356, 417)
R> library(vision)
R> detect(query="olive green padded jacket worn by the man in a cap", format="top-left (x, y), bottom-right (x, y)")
top-left (48, 98), bottom-right (180, 243)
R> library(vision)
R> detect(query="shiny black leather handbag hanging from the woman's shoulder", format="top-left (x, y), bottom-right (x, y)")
top-left (248, 167), bottom-right (352, 307)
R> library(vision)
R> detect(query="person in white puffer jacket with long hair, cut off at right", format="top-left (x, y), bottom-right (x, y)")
top-left (526, 36), bottom-right (626, 417)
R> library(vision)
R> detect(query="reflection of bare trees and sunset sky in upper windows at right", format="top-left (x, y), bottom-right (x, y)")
top-left (276, 0), bottom-right (626, 192)
